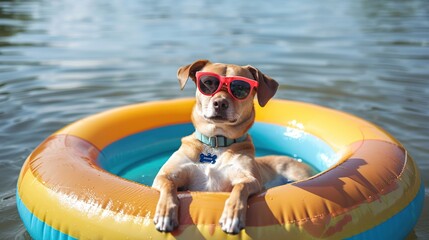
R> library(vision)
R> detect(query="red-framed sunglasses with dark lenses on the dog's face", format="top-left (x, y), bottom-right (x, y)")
top-left (196, 72), bottom-right (258, 100)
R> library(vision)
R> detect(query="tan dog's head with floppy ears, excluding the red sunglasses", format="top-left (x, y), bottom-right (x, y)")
top-left (177, 60), bottom-right (278, 138)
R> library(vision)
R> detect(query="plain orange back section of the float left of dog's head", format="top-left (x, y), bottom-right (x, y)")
top-left (56, 99), bottom-right (195, 149)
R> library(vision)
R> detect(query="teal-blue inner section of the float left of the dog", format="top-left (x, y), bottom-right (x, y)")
top-left (98, 124), bottom-right (194, 186)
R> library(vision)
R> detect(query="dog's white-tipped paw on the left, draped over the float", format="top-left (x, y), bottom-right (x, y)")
top-left (153, 198), bottom-right (179, 232)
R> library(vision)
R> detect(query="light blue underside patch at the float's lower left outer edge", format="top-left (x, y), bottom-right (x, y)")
top-left (16, 192), bottom-right (76, 240)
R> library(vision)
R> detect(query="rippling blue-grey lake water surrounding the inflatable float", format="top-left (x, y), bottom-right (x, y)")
top-left (0, 0), bottom-right (429, 239)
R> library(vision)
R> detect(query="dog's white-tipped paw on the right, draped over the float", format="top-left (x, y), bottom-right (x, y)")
top-left (219, 199), bottom-right (246, 234)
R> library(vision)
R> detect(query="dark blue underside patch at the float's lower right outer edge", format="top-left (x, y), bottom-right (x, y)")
top-left (347, 182), bottom-right (425, 240)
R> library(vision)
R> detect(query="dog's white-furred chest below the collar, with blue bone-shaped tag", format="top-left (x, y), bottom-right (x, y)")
top-left (188, 147), bottom-right (235, 192)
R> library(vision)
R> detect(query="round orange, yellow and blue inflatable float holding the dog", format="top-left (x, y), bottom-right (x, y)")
top-left (17, 99), bottom-right (424, 239)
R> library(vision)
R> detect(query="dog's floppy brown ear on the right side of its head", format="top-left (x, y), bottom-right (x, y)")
top-left (246, 65), bottom-right (279, 107)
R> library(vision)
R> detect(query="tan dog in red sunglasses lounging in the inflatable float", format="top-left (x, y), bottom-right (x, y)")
top-left (152, 60), bottom-right (313, 234)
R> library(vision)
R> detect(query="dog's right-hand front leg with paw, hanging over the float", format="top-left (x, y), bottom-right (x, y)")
top-left (219, 179), bottom-right (261, 234)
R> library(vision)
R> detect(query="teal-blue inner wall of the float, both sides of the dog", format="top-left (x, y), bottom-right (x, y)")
top-left (98, 122), bottom-right (335, 186)
